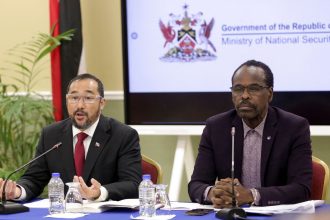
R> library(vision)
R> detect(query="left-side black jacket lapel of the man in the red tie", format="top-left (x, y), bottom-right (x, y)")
top-left (58, 120), bottom-right (76, 181)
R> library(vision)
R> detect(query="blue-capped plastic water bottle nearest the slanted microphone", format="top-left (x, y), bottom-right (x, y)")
top-left (48, 173), bottom-right (64, 214)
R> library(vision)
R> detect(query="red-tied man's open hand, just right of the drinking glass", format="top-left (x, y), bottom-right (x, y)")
top-left (73, 176), bottom-right (101, 200)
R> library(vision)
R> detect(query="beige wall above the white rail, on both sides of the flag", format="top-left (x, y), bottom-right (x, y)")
top-left (0, 0), bottom-right (123, 91)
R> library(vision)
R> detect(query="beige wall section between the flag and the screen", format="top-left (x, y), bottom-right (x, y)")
top-left (81, 0), bottom-right (123, 91)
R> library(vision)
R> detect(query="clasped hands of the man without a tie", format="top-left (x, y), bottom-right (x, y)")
top-left (208, 178), bottom-right (253, 208)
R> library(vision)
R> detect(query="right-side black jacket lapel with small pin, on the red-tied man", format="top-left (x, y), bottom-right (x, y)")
top-left (83, 115), bottom-right (110, 181)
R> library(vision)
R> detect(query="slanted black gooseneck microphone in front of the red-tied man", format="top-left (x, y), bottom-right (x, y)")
top-left (0, 142), bottom-right (62, 214)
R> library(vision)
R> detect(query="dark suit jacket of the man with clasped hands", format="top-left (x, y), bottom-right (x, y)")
top-left (188, 107), bottom-right (312, 205)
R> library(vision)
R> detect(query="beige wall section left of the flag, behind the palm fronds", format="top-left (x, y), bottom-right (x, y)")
top-left (0, 0), bottom-right (50, 91)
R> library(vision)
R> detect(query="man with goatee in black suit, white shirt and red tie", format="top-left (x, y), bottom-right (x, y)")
top-left (0, 74), bottom-right (142, 201)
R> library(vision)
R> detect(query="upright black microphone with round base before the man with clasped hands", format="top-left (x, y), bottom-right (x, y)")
top-left (215, 126), bottom-right (246, 220)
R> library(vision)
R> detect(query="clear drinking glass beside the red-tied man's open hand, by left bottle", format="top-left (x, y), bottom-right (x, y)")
top-left (65, 182), bottom-right (83, 212)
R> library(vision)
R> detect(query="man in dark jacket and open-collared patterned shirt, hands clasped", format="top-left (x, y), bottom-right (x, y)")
top-left (188, 60), bottom-right (312, 208)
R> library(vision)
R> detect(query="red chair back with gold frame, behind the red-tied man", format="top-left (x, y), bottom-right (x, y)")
top-left (142, 154), bottom-right (163, 184)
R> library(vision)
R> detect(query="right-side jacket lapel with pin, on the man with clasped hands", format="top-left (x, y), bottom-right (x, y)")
top-left (260, 107), bottom-right (277, 186)
